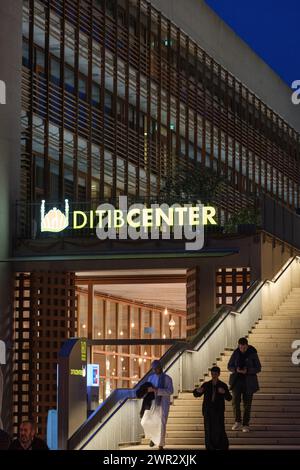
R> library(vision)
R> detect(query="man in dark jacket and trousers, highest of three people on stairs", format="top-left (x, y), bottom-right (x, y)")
top-left (228, 338), bottom-right (261, 432)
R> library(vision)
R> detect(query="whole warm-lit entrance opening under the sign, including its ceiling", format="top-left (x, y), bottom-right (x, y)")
top-left (76, 269), bottom-right (186, 402)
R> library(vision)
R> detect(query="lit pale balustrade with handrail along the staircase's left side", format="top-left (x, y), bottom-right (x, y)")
top-left (68, 257), bottom-right (300, 450)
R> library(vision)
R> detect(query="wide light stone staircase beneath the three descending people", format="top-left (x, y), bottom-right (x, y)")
top-left (131, 288), bottom-right (300, 449)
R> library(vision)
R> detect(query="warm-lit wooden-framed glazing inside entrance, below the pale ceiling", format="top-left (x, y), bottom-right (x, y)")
top-left (77, 285), bottom-right (186, 400)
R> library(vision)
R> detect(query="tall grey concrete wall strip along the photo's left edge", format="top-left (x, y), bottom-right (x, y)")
top-left (0, 0), bottom-right (22, 431)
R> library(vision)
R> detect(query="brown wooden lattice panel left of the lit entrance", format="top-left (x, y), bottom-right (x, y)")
top-left (14, 272), bottom-right (76, 436)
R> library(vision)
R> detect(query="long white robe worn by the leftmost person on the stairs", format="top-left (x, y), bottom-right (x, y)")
top-left (141, 374), bottom-right (174, 447)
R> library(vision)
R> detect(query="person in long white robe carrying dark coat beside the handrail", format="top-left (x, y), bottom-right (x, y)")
top-left (141, 361), bottom-right (174, 449)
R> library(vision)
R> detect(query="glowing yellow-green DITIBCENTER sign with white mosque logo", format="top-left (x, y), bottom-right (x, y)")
top-left (41, 196), bottom-right (217, 250)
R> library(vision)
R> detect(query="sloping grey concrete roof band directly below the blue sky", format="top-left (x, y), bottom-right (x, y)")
top-left (151, 0), bottom-right (300, 132)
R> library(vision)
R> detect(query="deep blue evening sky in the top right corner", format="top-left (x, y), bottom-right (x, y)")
top-left (205, 0), bottom-right (300, 86)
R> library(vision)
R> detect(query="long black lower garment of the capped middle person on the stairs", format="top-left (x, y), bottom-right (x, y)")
top-left (203, 407), bottom-right (229, 450)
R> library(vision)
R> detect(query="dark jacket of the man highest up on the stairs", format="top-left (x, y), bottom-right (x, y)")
top-left (227, 346), bottom-right (261, 394)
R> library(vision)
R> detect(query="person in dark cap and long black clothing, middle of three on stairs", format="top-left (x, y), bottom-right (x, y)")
top-left (193, 366), bottom-right (232, 450)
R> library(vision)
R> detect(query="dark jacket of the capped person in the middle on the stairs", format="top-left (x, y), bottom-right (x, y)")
top-left (193, 380), bottom-right (232, 416)
